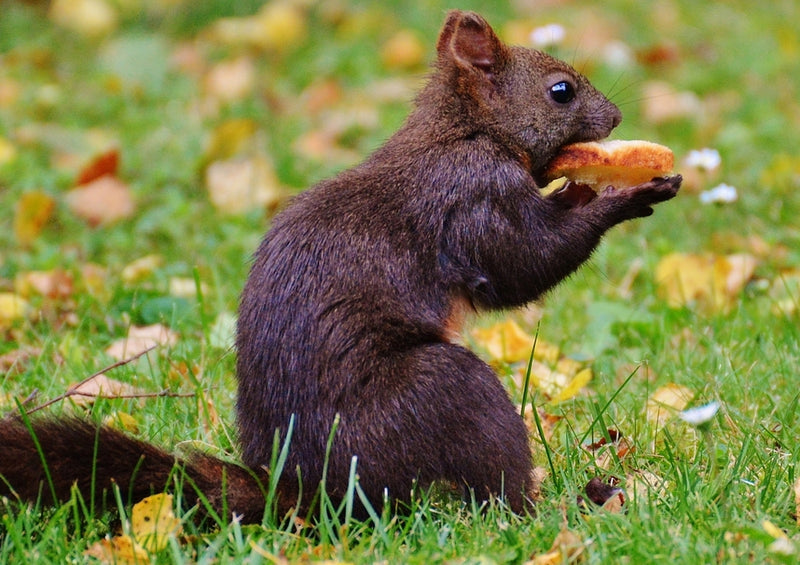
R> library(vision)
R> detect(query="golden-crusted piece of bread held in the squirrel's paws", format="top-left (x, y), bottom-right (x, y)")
top-left (544, 139), bottom-right (675, 191)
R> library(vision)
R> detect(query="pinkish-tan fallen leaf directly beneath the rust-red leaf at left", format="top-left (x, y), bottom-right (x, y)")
top-left (64, 175), bottom-right (135, 227)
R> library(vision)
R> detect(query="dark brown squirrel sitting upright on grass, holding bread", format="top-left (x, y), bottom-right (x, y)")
top-left (0, 11), bottom-right (681, 521)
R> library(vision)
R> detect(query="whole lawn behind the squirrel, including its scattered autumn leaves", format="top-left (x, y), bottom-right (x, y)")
top-left (0, 0), bottom-right (800, 563)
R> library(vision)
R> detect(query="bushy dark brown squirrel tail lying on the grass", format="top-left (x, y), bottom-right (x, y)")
top-left (0, 418), bottom-right (298, 523)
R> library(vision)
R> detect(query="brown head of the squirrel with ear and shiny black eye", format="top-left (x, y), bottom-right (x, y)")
top-left (436, 11), bottom-right (622, 181)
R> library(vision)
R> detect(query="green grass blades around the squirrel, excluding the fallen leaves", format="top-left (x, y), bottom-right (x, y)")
top-left (0, 0), bottom-right (800, 563)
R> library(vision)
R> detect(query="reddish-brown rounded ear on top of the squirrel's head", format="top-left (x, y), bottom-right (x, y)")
top-left (436, 10), bottom-right (503, 79)
